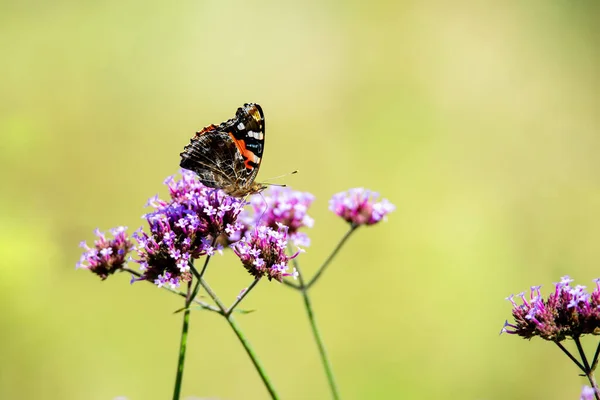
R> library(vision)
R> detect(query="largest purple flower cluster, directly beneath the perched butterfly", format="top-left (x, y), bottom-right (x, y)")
top-left (134, 171), bottom-right (245, 287)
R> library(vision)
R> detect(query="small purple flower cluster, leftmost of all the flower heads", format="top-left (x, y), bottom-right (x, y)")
top-left (76, 226), bottom-right (133, 280)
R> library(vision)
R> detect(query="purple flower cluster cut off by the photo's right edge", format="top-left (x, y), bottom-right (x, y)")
top-left (502, 276), bottom-right (600, 342)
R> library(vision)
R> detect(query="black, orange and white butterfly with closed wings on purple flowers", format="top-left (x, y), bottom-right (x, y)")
top-left (179, 103), bottom-right (266, 197)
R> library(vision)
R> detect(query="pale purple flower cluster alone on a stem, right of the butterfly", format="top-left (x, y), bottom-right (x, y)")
top-left (329, 188), bottom-right (396, 226)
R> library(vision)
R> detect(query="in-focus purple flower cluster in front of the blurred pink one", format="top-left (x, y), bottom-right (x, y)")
top-left (232, 225), bottom-right (300, 282)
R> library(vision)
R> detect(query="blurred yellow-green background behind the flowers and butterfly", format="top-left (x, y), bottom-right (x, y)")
top-left (0, 0), bottom-right (600, 400)
